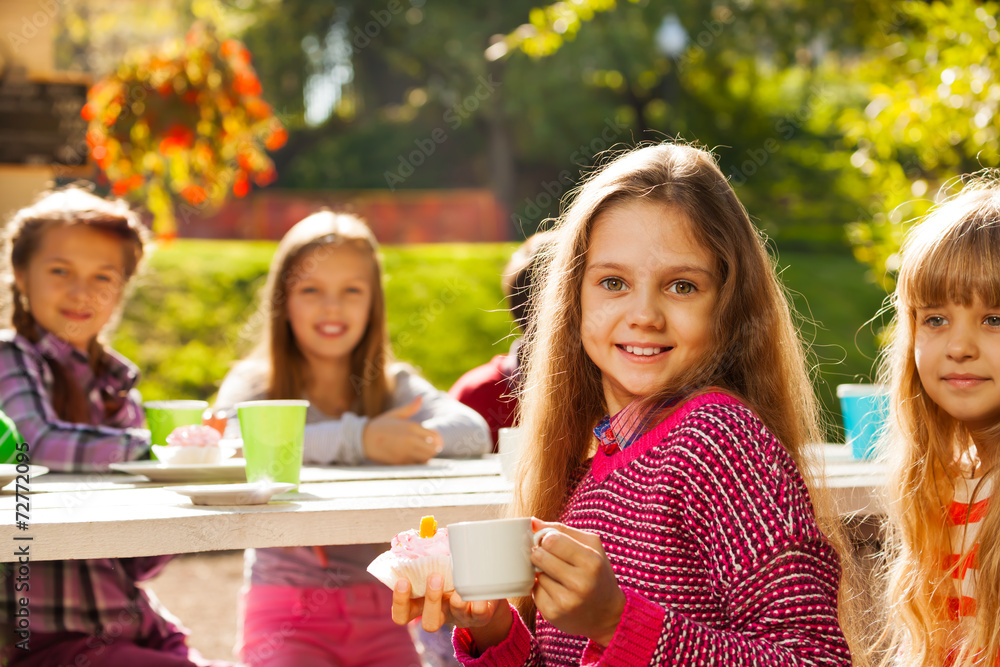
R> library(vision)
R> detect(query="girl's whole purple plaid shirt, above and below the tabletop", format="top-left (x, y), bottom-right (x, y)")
top-left (0, 330), bottom-right (175, 644)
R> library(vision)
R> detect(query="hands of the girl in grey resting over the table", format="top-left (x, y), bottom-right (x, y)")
top-left (362, 396), bottom-right (444, 465)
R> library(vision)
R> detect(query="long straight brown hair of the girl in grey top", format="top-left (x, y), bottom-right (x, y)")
top-left (250, 211), bottom-right (394, 417)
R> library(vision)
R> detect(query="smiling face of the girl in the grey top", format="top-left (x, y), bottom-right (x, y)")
top-left (288, 245), bottom-right (375, 363)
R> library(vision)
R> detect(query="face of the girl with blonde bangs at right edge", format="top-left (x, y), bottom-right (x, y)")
top-left (914, 298), bottom-right (1000, 431)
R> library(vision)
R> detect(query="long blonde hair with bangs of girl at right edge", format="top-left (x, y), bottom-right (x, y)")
top-left (881, 179), bottom-right (1000, 667)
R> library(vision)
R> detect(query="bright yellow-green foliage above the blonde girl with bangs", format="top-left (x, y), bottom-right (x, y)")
top-left (839, 0), bottom-right (1000, 289)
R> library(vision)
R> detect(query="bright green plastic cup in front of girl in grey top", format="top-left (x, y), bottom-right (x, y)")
top-left (236, 400), bottom-right (309, 485)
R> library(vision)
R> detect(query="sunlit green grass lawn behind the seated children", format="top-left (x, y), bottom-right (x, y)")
top-left (113, 240), bottom-right (884, 444)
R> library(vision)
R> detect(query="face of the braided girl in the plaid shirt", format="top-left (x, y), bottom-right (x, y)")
top-left (14, 225), bottom-right (125, 352)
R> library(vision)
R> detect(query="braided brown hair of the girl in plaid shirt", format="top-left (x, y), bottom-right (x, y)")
top-left (4, 186), bottom-right (148, 423)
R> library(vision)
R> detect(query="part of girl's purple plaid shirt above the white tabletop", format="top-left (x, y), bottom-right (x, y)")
top-left (0, 330), bottom-right (149, 472)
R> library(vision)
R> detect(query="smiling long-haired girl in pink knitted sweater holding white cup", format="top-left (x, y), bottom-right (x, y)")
top-left (393, 144), bottom-right (850, 665)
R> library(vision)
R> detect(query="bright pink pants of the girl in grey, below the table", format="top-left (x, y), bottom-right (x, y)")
top-left (236, 584), bottom-right (420, 667)
